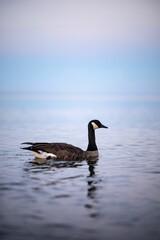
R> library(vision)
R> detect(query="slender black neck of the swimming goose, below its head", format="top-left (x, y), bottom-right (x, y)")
top-left (87, 124), bottom-right (98, 151)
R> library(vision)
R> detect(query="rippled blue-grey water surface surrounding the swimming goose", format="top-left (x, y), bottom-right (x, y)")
top-left (0, 94), bottom-right (160, 240)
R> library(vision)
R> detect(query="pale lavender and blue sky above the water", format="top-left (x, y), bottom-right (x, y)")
top-left (0, 0), bottom-right (160, 94)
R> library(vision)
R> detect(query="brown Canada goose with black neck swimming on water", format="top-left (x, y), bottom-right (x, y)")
top-left (22, 120), bottom-right (108, 160)
